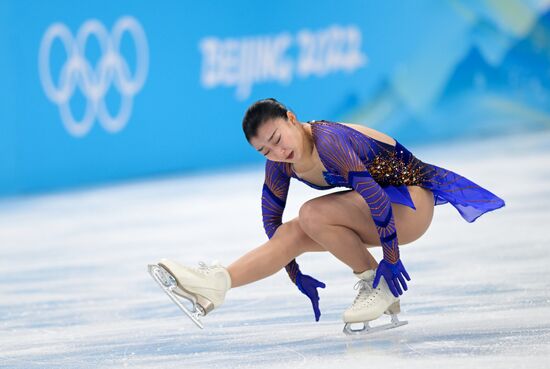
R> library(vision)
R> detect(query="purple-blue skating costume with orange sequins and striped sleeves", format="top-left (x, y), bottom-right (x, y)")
top-left (262, 121), bottom-right (504, 318)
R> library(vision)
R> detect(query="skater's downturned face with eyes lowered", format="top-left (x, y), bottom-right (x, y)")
top-left (250, 113), bottom-right (303, 163)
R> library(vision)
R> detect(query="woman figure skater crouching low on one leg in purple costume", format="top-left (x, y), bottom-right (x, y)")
top-left (152, 99), bottom-right (504, 327)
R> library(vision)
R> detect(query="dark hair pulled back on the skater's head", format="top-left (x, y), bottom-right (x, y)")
top-left (243, 98), bottom-right (288, 142)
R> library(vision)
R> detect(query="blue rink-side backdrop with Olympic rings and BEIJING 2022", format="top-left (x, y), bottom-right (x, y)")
top-left (0, 0), bottom-right (550, 195)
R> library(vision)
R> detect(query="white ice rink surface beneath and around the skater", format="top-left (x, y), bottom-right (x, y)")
top-left (0, 133), bottom-right (550, 369)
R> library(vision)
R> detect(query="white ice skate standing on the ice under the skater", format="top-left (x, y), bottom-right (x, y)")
top-left (343, 270), bottom-right (408, 334)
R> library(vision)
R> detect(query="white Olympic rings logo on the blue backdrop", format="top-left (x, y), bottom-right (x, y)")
top-left (38, 16), bottom-right (149, 137)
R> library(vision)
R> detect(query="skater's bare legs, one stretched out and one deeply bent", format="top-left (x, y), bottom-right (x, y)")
top-left (228, 186), bottom-right (433, 287)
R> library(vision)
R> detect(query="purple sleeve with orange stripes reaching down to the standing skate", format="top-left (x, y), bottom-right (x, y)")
top-left (315, 127), bottom-right (399, 264)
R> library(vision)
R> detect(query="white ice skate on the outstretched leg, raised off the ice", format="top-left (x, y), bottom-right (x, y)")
top-left (148, 259), bottom-right (231, 328)
